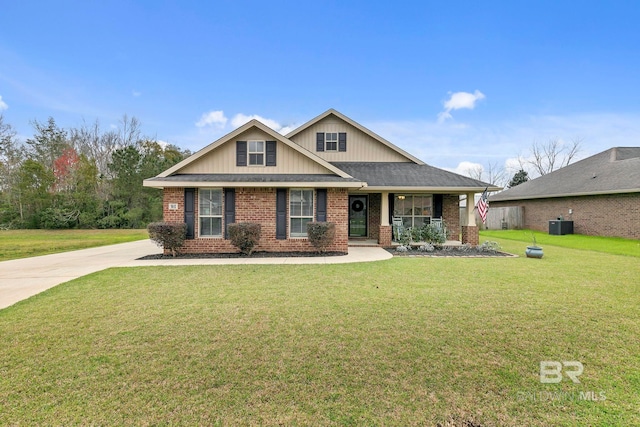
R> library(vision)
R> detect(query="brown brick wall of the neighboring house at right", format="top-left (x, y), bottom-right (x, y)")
top-left (490, 193), bottom-right (640, 239)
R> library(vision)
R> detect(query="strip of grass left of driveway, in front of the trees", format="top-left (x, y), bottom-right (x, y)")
top-left (0, 229), bottom-right (149, 261)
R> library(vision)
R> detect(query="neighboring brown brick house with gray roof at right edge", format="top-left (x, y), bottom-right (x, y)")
top-left (489, 147), bottom-right (640, 239)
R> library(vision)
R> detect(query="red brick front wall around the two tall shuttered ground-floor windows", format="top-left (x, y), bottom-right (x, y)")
top-left (163, 188), bottom-right (348, 253)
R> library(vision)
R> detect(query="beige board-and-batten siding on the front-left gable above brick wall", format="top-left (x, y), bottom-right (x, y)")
top-left (177, 129), bottom-right (333, 175)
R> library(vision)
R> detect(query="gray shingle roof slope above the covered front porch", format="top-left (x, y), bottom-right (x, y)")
top-left (331, 162), bottom-right (492, 190)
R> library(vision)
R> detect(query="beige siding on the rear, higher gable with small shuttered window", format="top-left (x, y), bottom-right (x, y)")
top-left (291, 115), bottom-right (411, 162)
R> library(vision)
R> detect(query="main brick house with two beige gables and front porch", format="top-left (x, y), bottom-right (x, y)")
top-left (144, 109), bottom-right (499, 253)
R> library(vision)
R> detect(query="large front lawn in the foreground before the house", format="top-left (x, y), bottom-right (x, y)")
top-left (0, 239), bottom-right (640, 427)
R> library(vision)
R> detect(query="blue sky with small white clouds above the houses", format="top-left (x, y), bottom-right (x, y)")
top-left (0, 0), bottom-right (640, 181)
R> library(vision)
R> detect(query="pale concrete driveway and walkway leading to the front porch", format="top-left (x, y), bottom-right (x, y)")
top-left (0, 240), bottom-right (392, 309)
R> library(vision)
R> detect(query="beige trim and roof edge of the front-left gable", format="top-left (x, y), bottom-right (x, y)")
top-left (157, 119), bottom-right (351, 181)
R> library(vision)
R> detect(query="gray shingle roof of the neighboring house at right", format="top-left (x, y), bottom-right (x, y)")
top-left (489, 147), bottom-right (640, 202)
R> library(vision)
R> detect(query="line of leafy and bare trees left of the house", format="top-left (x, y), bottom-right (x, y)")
top-left (0, 114), bottom-right (191, 229)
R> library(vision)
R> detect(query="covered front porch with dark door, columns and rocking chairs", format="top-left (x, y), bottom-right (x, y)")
top-left (348, 188), bottom-right (479, 247)
